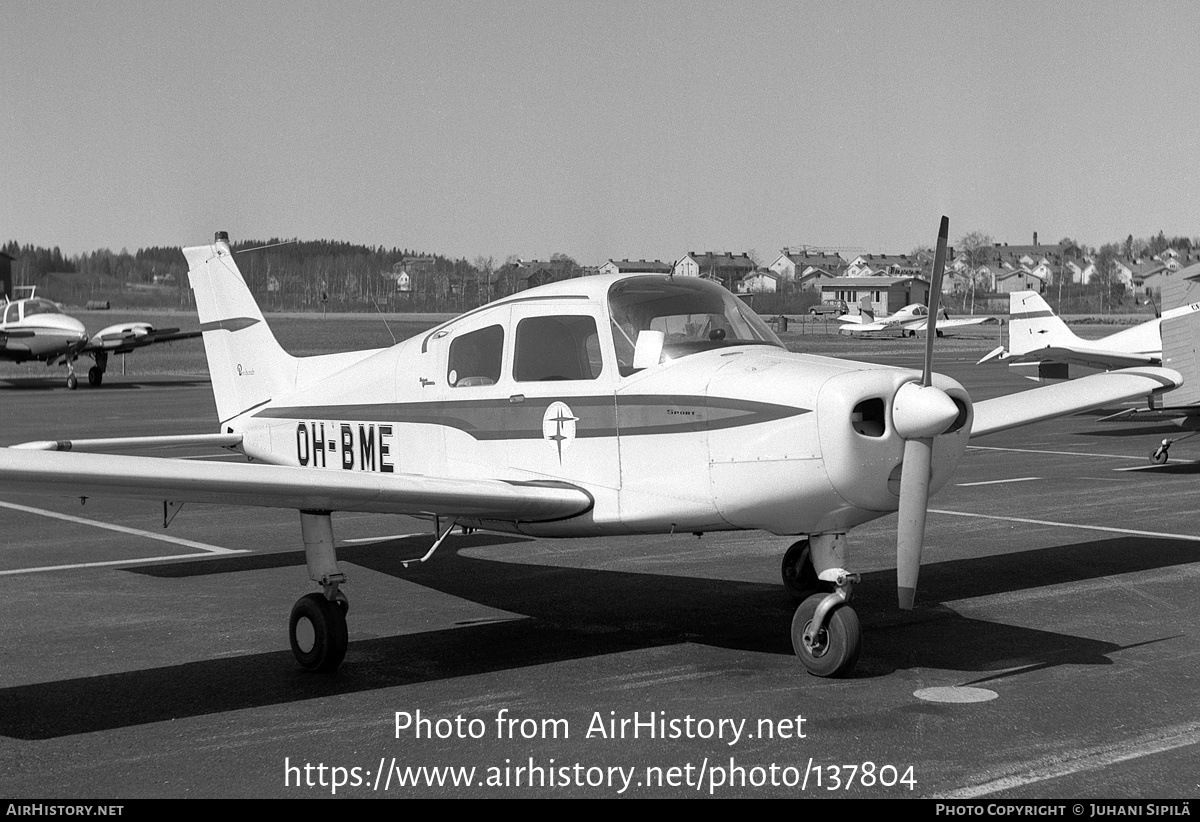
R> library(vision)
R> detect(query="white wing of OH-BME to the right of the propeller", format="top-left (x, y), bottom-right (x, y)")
top-left (971, 367), bottom-right (1183, 439)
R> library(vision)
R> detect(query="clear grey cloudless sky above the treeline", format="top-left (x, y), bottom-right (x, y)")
top-left (7, 0), bottom-right (1200, 265)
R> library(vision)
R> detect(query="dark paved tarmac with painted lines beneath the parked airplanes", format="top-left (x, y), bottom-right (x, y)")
top-left (0, 341), bottom-right (1200, 802)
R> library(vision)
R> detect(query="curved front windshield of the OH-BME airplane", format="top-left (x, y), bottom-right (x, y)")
top-left (608, 276), bottom-right (784, 376)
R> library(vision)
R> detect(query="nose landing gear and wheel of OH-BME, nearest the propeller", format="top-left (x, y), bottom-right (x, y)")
top-left (785, 534), bottom-right (862, 677)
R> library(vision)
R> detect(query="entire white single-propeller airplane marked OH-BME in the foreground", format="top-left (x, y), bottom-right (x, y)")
top-left (0, 217), bottom-right (1180, 676)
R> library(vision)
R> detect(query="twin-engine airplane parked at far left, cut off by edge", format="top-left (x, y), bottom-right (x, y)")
top-left (0, 285), bottom-right (200, 390)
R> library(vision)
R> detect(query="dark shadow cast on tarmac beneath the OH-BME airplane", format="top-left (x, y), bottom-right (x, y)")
top-left (0, 534), bottom-right (1194, 739)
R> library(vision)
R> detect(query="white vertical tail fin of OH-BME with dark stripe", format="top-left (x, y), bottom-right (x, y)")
top-left (184, 232), bottom-right (298, 424)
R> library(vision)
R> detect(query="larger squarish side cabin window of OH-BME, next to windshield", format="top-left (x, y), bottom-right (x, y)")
top-left (512, 314), bottom-right (604, 383)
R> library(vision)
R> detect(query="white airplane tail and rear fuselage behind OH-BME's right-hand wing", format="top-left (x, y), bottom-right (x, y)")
top-left (979, 286), bottom-right (1200, 379)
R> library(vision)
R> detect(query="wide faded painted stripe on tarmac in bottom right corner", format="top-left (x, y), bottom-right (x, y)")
top-left (935, 721), bottom-right (1200, 799)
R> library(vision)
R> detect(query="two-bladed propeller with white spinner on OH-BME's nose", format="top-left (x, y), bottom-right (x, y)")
top-left (892, 216), bottom-right (959, 611)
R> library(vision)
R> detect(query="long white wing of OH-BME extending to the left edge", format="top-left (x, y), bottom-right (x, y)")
top-left (0, 448), bottom-right (592, 522)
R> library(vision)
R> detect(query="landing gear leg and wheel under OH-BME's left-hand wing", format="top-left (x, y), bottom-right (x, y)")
top-left (288, 511), bottom-right (350, 672)
